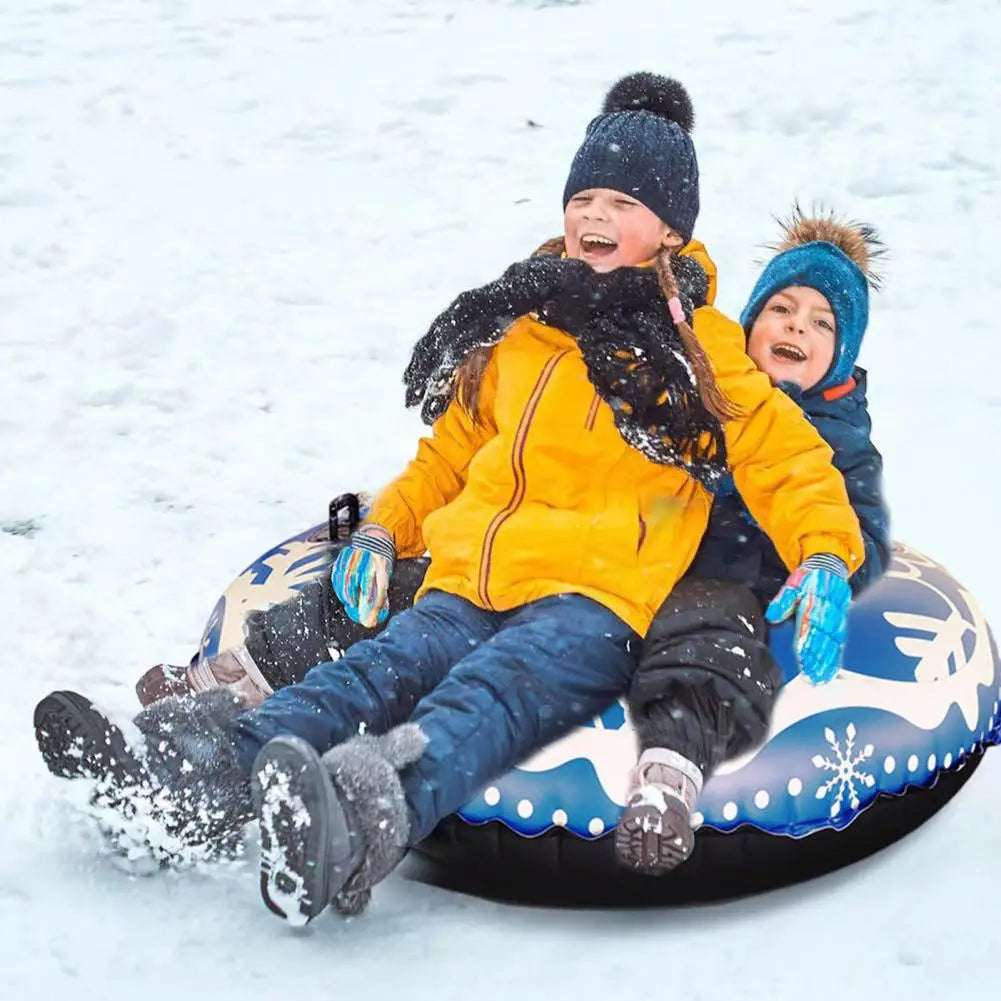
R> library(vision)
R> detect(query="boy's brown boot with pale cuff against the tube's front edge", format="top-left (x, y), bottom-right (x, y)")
top-left (615, 748), bottom-right (702, 876)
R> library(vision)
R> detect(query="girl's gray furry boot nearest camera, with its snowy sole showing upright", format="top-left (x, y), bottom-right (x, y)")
top-left (252, 724), bottom-right (426, 925)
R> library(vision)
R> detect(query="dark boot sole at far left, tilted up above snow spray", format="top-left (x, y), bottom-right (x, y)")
top-left (33, 692), bottom-right (141, 782)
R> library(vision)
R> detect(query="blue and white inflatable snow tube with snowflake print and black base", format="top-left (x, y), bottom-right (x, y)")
top-left (198, 527), bottom-right (1001, 905)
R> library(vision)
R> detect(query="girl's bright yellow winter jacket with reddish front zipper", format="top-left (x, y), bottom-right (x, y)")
top-left (368, 244), bottom-right (864, 635)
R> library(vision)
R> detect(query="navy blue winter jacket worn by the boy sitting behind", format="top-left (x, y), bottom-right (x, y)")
top-left (689, 368), bottom-right (890, 604)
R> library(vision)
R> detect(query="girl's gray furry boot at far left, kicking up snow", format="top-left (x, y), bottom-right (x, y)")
top-left (35, 691), bottom-right (251, 864)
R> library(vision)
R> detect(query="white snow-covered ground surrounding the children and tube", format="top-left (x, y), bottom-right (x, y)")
top-left (0, 0), bottom-right (1001, 1001)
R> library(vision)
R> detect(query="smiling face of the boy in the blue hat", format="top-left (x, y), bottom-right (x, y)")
top-left (748, 285), bottom-right (838, 390)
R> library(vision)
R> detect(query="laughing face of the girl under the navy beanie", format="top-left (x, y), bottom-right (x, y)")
top-left (564, 188), bottom-right (683, 271)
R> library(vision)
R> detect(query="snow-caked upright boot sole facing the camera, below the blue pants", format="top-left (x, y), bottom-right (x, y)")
top-left (251, 737), bottom-right (356, 925)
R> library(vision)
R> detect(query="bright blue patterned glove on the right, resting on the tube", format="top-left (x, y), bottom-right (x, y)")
top-left (765, 553), bottom-right (852, 685)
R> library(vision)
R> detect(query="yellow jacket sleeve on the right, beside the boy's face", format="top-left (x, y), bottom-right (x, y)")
top-left (695, 307), bottom-right (865, 574)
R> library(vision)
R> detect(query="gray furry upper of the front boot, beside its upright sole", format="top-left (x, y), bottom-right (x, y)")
top-left (323, 723), bottom-right (427, 916)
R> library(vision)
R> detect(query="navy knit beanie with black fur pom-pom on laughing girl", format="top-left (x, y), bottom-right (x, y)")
top-left (564, 73), bottom-right (699, 242)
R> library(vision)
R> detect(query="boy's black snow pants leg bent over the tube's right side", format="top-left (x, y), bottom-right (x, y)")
top-left (629, 577), bottom-right (782, 779)
